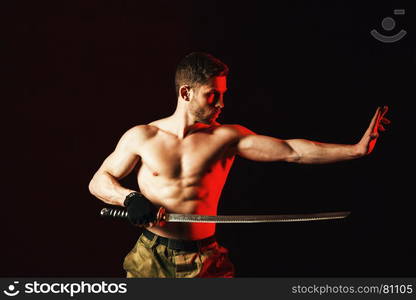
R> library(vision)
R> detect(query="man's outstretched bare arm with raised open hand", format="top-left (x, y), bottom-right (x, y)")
top-left (237, 106), bottom-right (390, 164)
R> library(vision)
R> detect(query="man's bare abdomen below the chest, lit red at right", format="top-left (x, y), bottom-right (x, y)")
top-left (137, 165), bottom-right (228, 240)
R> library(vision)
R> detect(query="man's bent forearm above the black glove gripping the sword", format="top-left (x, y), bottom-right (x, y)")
top-left (88, 172), bottom-right (133, 206)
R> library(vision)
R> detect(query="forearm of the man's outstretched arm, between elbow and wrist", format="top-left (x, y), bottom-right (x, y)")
top-left (286, 139), bottom-right (363, 164)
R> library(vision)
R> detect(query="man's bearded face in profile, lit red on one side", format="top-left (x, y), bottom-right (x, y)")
top-left (189, 76), bottom-right (227, 124)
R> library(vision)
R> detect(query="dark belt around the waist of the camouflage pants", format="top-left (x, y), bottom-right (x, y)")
top-left (143, 229), bottom-right (216, 252)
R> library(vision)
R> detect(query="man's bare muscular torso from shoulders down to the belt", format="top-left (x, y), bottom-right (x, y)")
top-left (137, 122), bottom-right (237, 239)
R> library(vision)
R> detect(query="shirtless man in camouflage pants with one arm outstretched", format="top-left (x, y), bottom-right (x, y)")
top-left (89, 53), bottom-right (390, 277)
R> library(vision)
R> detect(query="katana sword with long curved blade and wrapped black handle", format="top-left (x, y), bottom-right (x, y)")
top-left (100, 207), bottom-right (351, 223)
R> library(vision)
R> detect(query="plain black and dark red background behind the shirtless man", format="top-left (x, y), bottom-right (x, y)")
top-left (4, 0), bottom-right (416, 277)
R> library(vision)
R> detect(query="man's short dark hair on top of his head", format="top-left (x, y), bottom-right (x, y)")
top-left (175, 52), bottom-right (229, 96)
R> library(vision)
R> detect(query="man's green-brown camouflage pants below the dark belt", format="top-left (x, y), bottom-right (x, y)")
top-left (123, 234), bottom-right (234, 278)
